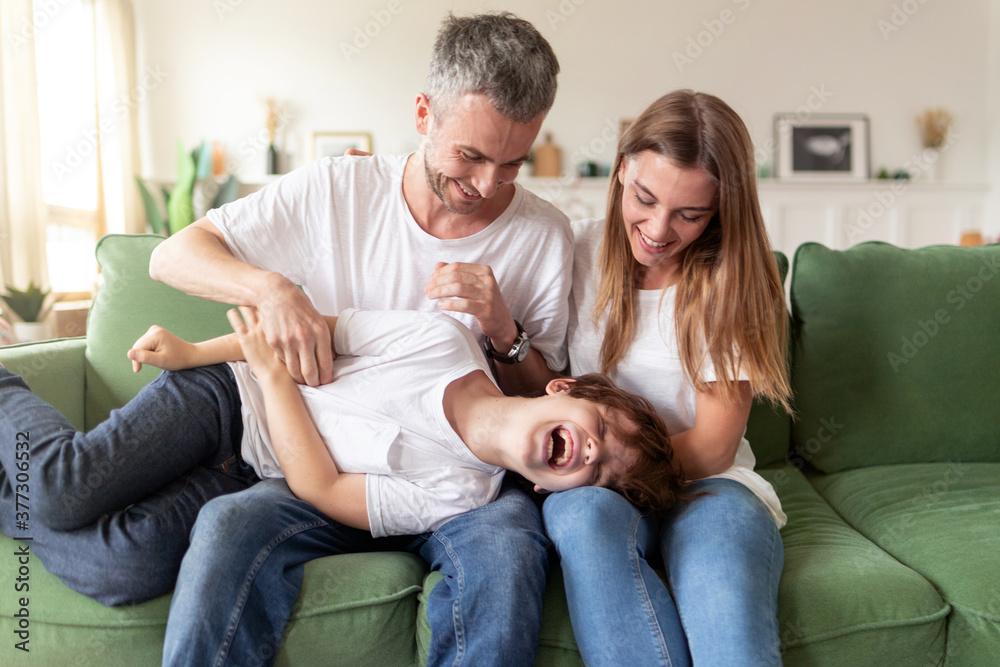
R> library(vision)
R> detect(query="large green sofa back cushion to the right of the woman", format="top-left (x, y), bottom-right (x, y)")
top-left (791, 242), bottom-right (1000, 473)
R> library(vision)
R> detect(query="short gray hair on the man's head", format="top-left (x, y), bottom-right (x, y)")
top-left (424, 12), bottom-right (559, 123)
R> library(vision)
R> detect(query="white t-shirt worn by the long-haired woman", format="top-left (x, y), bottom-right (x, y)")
top-left (569, 220), bottom-right (786, 528)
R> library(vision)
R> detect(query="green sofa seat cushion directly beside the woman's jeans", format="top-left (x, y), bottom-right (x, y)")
top-left (758, 465), bottom-right (949, 665)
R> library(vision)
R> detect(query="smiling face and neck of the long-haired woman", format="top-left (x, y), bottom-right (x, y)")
top-left (618, 151), bottom-right (719, 289)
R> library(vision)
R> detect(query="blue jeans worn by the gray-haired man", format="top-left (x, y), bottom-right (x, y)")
top-left (163, 479), bottom-right (548, 665)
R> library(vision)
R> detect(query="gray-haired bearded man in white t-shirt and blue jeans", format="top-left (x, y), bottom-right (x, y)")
top-left (150, 14), bottom-right (572, 665)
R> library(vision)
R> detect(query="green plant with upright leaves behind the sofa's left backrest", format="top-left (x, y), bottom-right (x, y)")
top-left (135, 142), bottom-right (239, 236)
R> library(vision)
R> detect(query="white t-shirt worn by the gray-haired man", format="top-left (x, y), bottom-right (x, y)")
top-left (208, 155), bottom-right (573, 370)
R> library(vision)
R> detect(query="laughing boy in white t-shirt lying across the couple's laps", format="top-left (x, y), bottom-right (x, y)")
top-left (0, 308), bottom-right (680, 562)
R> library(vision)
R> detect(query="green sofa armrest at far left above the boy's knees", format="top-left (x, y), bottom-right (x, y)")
top-left (0, 337), bottom-right (87, 430)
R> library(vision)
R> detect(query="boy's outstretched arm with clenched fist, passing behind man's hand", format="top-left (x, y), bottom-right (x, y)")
top-left (127, 317), bottom-right (337, 373)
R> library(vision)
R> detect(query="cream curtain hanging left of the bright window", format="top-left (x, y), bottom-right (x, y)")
top-left (0, 0), bottom-right (49, 289)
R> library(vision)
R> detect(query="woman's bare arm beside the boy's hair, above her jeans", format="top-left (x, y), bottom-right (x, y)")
top-left (670, 382), bottom-right (753, 479)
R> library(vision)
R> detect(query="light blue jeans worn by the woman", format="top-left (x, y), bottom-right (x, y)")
top-left (543, 479), bottom-right (784, 667)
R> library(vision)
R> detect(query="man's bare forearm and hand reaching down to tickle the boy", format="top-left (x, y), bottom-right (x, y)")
top-left (149, 218), bottom-right (333, 386)
